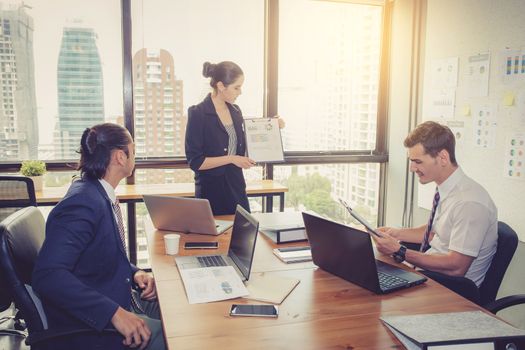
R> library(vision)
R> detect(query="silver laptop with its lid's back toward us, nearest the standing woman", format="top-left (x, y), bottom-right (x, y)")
top-left (143, 195), bottom-right (233, 235)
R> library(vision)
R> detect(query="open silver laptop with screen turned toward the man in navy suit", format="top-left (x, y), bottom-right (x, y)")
top-left (175, 205), bottom-right (259, 281)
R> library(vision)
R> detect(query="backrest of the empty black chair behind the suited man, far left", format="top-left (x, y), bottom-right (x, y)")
top-left (0, 175), bottom-right (36, 220)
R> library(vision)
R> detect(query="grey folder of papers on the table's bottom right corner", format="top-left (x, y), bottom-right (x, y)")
top-left (381, 311), bottom-right (525, 350)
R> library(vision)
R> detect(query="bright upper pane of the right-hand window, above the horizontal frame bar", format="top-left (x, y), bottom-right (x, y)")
top-left (278, 0), bottom-right (382, 151)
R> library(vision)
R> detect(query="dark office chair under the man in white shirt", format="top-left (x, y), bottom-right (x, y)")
top-left (422, 221), bottom-right (525, 314)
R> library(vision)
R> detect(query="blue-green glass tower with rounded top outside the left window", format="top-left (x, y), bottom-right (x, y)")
top-left (55, 25), bottom-right (104, 159)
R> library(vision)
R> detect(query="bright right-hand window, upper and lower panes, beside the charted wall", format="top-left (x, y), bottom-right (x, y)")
top-left (274, 0), bottom-right (383, 222)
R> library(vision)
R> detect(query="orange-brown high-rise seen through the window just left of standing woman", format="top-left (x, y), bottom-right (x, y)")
top-left (133, 48), bottom-right (192, 183)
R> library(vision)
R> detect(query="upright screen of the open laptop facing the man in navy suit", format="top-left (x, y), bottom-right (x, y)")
top-left (228, 205), bottom-right (259, 279)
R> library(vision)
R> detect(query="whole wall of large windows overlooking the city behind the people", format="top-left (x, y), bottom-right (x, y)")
top-left (0, 0), bottom-right (386, 264)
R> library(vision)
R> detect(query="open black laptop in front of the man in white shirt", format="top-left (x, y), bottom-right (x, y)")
top-left (303, 213), bottom-right (427, 294)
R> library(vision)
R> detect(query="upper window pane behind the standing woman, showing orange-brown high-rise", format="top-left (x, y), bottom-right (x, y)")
top-left (132, 0), bottom-right (264, 157)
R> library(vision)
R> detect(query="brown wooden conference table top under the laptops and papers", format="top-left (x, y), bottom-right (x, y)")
top-left (147, 217), bottom-right (480, 350)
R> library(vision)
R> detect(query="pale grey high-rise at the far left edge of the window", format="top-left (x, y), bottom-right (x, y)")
top-left (0, 3), bottom-right (38, 160)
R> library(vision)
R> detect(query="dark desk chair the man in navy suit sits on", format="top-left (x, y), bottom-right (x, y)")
top-left (0, 207), bottom-right (116, 350)
